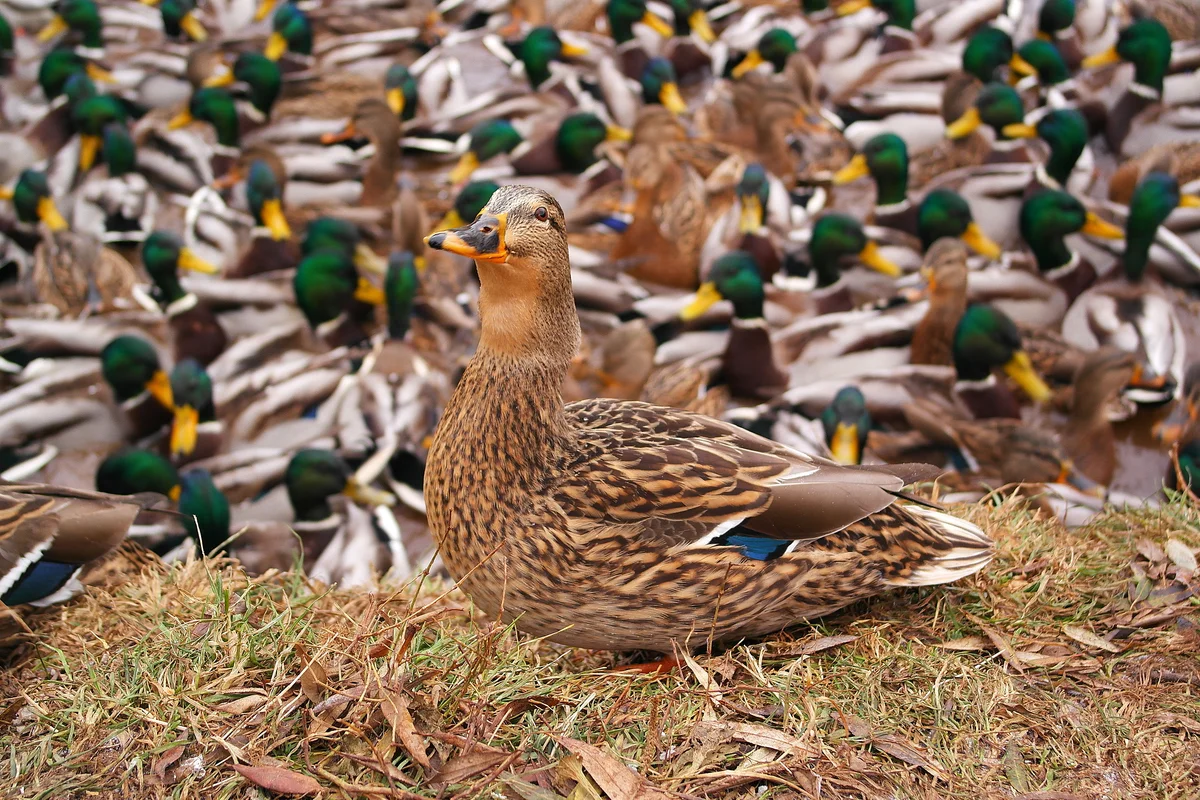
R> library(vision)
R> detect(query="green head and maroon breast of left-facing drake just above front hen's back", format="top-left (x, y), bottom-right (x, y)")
top-left (679, 249), bottom-right (787, 399)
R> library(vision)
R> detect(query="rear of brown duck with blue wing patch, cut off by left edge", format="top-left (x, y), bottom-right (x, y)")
top-left (0, 482), bottom-right (160, 606)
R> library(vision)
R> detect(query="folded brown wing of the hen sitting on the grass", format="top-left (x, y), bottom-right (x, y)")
top-left (554, 401), bottom-right (940, 551)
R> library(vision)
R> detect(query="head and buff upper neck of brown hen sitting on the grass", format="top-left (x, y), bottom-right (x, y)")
top-left (425, 186), bottom-right (580, 369)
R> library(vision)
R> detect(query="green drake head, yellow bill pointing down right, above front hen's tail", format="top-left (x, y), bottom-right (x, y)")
top-left (953, 303), bottom-right (1051, 403)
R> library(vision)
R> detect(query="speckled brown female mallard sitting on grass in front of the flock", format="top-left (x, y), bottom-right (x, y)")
top-left (425, 186), bottom-right (992, 652)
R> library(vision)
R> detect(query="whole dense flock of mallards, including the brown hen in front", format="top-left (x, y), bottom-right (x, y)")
top-left (0, 0), bottom-right (1200, 650)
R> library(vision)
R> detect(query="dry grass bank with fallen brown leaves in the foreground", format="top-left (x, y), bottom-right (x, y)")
top-left (0, 500), bottom-right (1200, 800)
